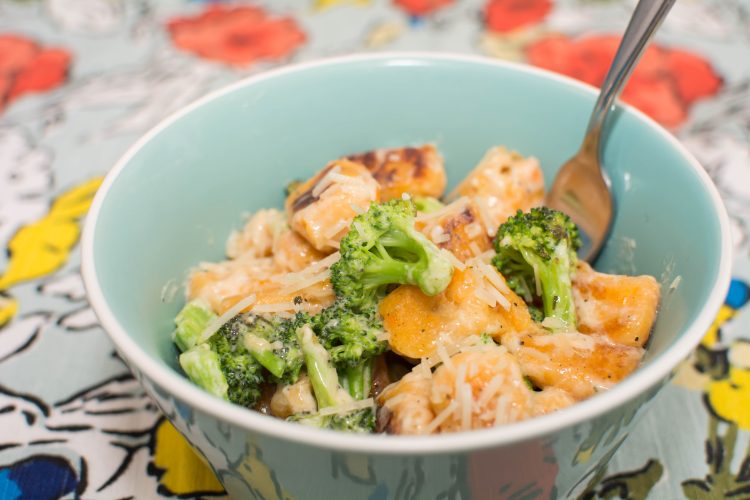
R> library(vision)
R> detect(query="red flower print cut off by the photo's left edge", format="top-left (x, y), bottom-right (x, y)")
top-left (0, 35), bottom-right (71, 112)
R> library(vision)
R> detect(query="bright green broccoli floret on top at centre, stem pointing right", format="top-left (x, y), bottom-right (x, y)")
top-left (331, 199), bottom-right (453, 309)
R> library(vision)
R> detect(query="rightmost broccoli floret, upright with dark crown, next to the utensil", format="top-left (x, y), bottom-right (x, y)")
top-left (493, 207), bottom-right (581, 330)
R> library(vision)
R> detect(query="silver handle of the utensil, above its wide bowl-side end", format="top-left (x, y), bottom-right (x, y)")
top-left (584, 0), bottom-right (675, 152)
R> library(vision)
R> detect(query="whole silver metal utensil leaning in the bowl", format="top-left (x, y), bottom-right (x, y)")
top-left (545, 0), bottom-right (675, 262)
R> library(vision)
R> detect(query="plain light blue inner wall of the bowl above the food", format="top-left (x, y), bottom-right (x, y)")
top-left (92, 56), bottom-right (722, 434)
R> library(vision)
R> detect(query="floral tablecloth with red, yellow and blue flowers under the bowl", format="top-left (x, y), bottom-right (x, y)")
top-left (0, 0), bottom-right (750, 499)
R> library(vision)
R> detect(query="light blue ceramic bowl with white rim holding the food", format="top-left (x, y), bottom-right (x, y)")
top-left (83, 54), bottom-right (730, 498)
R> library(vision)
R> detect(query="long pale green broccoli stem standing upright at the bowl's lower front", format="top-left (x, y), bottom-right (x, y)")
top-left (296, 324), bottom-right (351, 409)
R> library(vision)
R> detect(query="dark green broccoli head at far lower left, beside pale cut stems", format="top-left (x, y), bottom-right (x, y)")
top-left (208, 319), bottom-right (264, 407)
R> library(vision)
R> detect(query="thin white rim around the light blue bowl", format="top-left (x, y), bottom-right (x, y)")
top-left (81, 51), bottom-right (732, 455)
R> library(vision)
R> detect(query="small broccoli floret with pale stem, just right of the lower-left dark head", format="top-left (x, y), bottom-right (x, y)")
top-left (235, 313), bottom-right (308, 384)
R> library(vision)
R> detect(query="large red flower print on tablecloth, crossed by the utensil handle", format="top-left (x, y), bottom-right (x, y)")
top-left (526, 35), bottom-right (723, 128)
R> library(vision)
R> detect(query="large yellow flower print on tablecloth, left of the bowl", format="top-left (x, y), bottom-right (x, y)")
top-left (0, 177), bottom-right (102, 290)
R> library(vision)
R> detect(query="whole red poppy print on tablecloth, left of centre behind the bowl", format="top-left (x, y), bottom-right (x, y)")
top-left (167, 5), bottom-right (305, 66)
